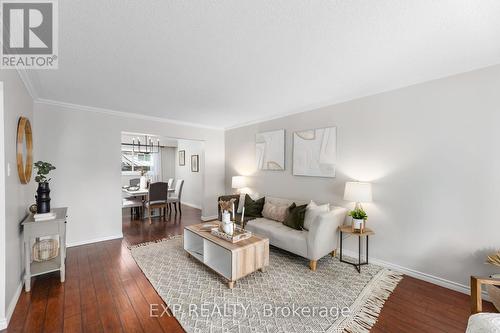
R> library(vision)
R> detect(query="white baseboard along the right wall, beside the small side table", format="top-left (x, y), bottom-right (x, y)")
top-left (337, 249), bottom-right (490, 301)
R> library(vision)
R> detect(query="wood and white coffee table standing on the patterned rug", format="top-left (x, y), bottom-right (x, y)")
top-left (184, 222), bottom-right (269, 289)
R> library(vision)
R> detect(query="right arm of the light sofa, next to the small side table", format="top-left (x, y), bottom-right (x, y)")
top-left (307, 207), bottom-right (347, 260)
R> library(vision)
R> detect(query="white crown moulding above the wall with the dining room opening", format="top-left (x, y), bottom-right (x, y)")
top-left (34, 98), bottom-right (224, 131)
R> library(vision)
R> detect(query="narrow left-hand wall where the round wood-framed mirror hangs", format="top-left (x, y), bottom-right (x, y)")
top-left (0, 71), bottom-right (34, 328)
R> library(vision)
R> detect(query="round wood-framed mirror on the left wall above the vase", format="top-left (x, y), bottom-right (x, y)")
top-left (17, 117), bottom-right (33, 184)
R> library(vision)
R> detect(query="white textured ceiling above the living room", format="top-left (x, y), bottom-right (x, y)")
top-left (30, 0), bottom-right (500, 128)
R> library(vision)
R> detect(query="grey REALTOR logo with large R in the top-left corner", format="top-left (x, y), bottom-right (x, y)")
top-left (0, 0), bottom-right (58, 69)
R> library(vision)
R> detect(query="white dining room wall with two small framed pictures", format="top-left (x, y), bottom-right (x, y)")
top-left (174, 140), bottom-right (205, 208)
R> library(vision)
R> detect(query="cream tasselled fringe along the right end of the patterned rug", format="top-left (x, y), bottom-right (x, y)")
top-left (344, 270), bottom-right (403, 333)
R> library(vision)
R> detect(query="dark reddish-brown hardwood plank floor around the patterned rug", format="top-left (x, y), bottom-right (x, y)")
top-left (6, 206), bottom-right (493, 333)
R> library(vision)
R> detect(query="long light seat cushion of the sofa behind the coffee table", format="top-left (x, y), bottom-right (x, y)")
top-left (246, 218), bottom-right (307, 257)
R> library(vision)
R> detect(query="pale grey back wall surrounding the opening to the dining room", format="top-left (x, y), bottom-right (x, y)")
top-left (35, 102), bottom-right (224, 245)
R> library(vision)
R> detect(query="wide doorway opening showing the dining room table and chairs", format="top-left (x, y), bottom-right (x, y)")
top-left (121, 132), bottom-right (205, 243)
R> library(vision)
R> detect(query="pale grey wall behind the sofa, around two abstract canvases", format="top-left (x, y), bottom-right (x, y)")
top-left (226, 66), bottom-right (500, 288)
